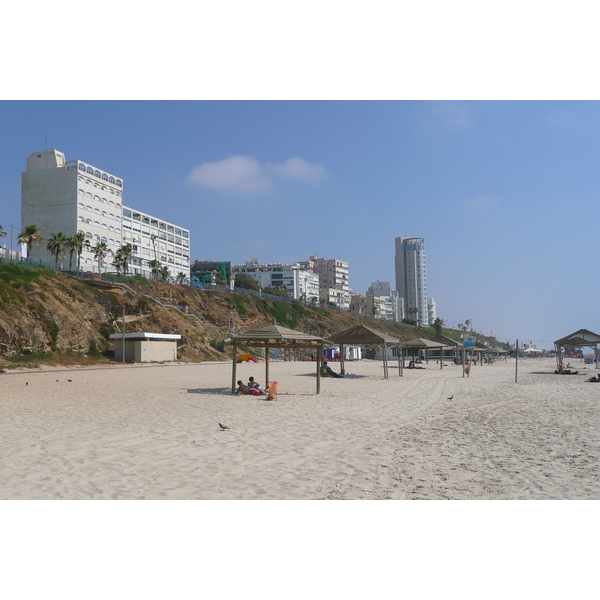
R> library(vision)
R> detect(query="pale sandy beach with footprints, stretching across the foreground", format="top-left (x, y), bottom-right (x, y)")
top-left (0, 359), bottom-right (600, 499)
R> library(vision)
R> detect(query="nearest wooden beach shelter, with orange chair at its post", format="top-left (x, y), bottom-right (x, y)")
top-left (230, 323), bottom-right (325, 394)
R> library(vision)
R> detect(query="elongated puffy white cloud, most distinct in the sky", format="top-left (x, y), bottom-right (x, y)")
top-left (187, 156), bottom-right (326, 193)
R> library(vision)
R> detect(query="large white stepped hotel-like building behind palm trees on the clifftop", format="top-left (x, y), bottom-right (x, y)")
top-left (21, 150), bottom-right (190, 278)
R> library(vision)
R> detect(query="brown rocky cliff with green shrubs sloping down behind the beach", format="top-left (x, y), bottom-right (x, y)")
top-left (0, 265), bottom-right (422, 365)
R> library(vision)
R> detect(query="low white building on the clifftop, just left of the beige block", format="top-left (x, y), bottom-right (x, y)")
top-left (231, 258), bottom-right (319, 302)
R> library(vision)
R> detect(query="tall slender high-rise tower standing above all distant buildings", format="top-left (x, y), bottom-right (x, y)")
top-left (395, 237), bottom-right (429, 325)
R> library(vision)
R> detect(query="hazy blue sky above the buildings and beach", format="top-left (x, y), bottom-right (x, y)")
top-left (0, 101), bottom-right (600, 347)
